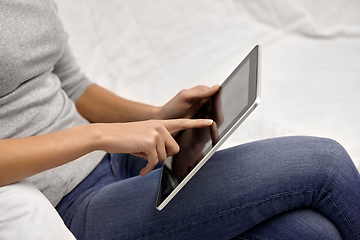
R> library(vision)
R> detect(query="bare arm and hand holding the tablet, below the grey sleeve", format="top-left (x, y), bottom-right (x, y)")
top-left (76, 84), bottom-right (219, 123)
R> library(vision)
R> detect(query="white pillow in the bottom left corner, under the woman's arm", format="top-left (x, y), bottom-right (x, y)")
top-left (0, 180), bottom-right (75, 240)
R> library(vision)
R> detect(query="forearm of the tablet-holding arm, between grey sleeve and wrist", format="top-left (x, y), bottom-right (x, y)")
top-left (76, 84), bottom-right (159, 123)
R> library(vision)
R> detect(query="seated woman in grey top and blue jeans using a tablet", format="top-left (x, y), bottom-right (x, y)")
top-left (0, 0), bottom-right (360, 239)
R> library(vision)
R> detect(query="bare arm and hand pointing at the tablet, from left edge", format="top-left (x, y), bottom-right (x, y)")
top-left (0, 119), bottom-right (212, 186)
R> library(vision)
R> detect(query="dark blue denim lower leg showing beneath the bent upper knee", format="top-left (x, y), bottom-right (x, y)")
top-left (233, 207), bottom-right (342, 240)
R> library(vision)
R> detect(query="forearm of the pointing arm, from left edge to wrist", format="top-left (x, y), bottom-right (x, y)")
top-left (0, 125), bottom-right (99, 186)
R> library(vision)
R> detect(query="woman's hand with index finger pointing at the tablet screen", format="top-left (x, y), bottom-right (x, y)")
top-left (97, 119), bottom-right (213, 176)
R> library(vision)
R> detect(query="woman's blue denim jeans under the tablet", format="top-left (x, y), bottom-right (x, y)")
top-left (57, 137), bottom-right (360, 240)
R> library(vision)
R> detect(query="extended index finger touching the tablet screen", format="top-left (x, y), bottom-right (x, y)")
top-left (163, 118), bottom-right (214, 133)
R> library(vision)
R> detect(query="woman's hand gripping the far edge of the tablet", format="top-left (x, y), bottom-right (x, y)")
top-left (156, 85), bottom-right (219, 119)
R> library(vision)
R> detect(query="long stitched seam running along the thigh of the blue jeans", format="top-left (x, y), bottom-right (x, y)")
top-left (142, 189), bottom-right (315, 239)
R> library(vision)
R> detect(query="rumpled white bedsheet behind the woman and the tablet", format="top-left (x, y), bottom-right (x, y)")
top-left (56, 0), bottom-right (360, 167)
